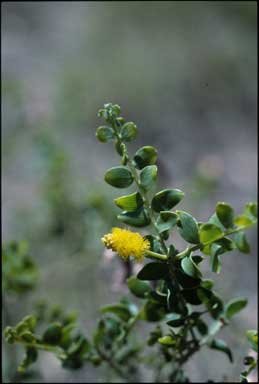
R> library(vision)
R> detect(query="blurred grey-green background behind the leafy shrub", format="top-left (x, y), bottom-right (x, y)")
top-left (2, 1), bottom-right (257, 382)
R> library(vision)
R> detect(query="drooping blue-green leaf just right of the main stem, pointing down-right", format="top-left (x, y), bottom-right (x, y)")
top-left (176, 211), bottom-right (200, 244)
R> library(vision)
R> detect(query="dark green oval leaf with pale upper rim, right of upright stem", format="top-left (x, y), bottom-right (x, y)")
top-left (152, 189), bottom-right (184, 212)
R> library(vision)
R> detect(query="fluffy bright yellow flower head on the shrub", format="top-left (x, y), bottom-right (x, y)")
top-left (102, 228), bottom-right (150, 262)
